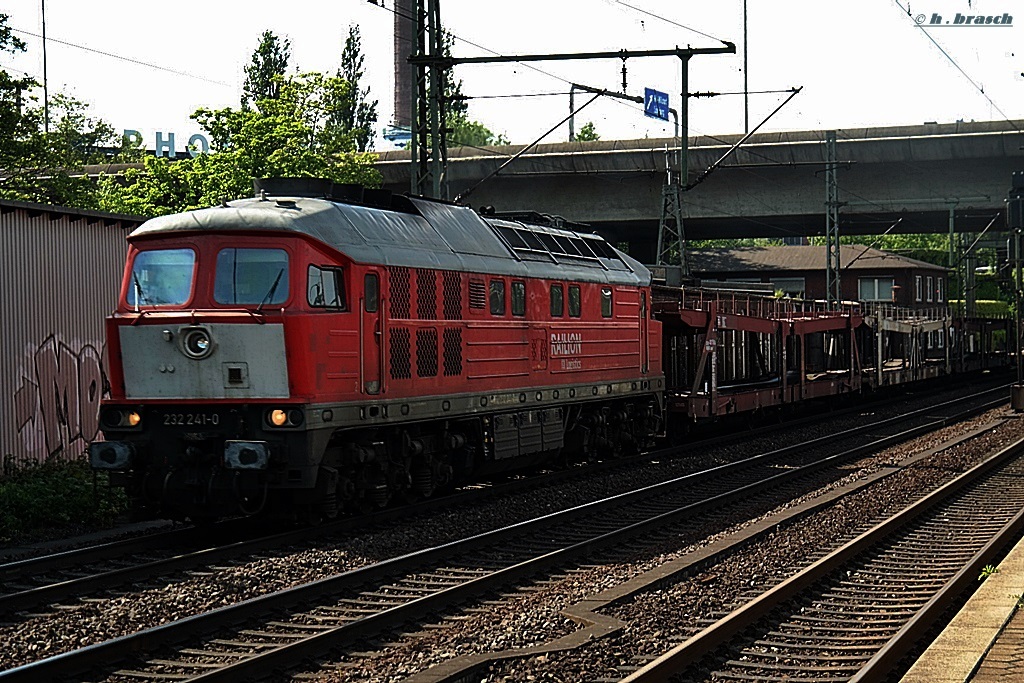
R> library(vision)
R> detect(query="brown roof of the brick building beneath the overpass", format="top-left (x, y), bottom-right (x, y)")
top-left (690, 245), bottom-right (948, 273)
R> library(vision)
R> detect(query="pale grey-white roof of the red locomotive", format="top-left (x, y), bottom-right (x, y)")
top-left (129, 197), bottom-right (650, 286)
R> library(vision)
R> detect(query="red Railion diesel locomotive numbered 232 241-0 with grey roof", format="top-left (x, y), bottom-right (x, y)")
top-left (89, 180), bottom-right (665, 519)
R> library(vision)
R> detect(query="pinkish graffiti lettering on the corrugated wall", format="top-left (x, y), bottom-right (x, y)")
top-left (13, 335), bottom-right (110, 463)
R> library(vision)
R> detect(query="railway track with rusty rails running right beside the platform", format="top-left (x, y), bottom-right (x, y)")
top-left (624, 430), bottom-right (1024, 683)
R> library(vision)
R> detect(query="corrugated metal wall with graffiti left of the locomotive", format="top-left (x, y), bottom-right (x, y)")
top-left (0, 202), bottom-right (140, 472)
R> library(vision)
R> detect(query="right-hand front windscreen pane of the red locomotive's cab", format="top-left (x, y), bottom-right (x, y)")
top-left (213, 247), bottom-right (288, 305)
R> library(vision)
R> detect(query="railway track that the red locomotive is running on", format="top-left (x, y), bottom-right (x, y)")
top-left (0, 378), bottom-right (1005, 622)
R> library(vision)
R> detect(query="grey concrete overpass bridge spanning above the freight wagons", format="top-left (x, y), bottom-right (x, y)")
top-left (377, 121), bottom-right (1024, 259)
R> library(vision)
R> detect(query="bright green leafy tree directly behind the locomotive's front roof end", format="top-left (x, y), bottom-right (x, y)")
top-left (99, 74), bottom-right (381, 216)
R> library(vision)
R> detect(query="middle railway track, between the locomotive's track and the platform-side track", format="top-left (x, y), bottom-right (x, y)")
top-left (0, 387), bottom-right (1005, 681)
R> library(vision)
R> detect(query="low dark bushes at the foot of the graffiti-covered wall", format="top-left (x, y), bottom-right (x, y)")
top-left (0, 460), bottom-right (127, 544)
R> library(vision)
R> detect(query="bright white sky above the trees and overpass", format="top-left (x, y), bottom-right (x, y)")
top-left (0, 0), bottom-right (1024, 150)
